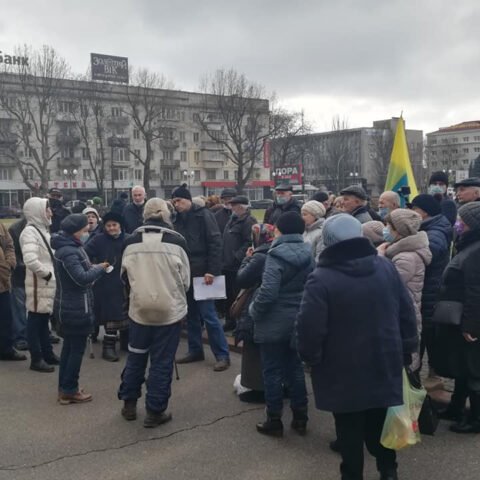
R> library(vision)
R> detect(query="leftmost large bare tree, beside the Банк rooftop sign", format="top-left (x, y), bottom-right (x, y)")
top-left (0, 46), bottom-right (70, 193)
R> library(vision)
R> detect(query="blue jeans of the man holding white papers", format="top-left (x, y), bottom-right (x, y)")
top-left (187, 288), bottom-right (230, 360)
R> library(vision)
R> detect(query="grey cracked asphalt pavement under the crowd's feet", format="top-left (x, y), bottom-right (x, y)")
top-left (0, 342), bottom-right (480, 480)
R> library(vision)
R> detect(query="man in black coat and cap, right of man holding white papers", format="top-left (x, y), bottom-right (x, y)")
top-left (223, 195), bottom-right (257, 331)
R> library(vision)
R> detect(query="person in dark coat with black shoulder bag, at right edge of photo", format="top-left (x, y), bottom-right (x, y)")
top-left (432, 202), bottom-right (480, 433)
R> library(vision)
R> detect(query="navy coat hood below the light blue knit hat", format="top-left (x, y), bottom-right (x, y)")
top-left (318, 237), bottom-right (379, 277)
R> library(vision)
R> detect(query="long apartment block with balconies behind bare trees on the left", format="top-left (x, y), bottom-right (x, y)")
top-left (0, 74), bottom-right (271, 206)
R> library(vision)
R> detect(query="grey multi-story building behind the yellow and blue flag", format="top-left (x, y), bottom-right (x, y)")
top-left (272, 118), bottom-right (423, 196)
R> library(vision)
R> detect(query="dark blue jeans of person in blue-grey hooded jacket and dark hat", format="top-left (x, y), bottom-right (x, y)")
top-left (259, 342), bottom-right (308, 415)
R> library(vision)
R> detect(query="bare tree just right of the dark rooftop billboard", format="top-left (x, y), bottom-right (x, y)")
top-left (124, 69), bottom-right (176, 193)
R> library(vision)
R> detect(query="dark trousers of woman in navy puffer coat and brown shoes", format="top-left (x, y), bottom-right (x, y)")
top-left (58, 335), bottom-right (87, 395)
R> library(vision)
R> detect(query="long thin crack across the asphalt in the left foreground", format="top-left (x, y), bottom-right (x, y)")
top-left (0, 405), bottom-right (265, 472)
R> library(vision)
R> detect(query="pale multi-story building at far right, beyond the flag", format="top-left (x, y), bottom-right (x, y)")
top-left (425, 120), bottom-right (480, 185)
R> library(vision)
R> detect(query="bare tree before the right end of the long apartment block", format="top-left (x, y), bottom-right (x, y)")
top-left (197, 69), bottom-right (281, 192)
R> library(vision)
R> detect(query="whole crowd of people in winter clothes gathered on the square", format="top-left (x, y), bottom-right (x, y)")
top-left (0, 172), bottom-right (480, 480)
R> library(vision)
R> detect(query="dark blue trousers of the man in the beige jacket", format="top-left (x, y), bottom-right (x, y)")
top-left (118, 320), bottom-right (181, 413)
